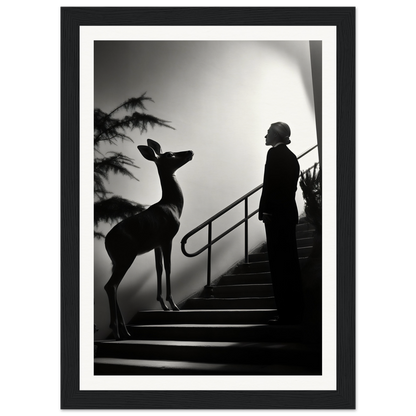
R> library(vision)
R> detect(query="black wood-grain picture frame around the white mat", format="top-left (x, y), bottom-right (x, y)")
top-left (56, 3), bottom-right (361, 415)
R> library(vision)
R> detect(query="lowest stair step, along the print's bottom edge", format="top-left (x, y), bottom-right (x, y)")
top-left (94, 358), bottom-right (321, 376)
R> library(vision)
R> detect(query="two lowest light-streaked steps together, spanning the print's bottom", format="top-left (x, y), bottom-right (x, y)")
top-left (95, 340), bottom-right (321, 375)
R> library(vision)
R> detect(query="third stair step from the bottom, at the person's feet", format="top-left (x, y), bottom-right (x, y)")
top-left (124, 324), bottom-right (302, 342)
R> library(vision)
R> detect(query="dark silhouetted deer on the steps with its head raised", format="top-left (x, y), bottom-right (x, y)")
top-left (104, 139), bottom-right (194, 340)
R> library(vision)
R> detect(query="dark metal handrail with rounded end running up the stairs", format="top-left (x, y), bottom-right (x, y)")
top-left (181, 145), bottom-right (318, 286)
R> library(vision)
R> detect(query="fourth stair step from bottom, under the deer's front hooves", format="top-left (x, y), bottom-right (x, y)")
top-left (130, 309), bottom-right (276, 325)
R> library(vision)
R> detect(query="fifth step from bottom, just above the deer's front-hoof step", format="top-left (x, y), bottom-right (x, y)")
top-left (182, 296), bottom-right (276, 309)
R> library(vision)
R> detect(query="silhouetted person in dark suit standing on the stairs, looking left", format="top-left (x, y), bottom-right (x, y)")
top-left (259, 122), bottom-right (303, 325)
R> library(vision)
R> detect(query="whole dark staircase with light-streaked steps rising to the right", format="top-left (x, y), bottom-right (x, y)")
top-left (94, 223), bottom-right (321, 375)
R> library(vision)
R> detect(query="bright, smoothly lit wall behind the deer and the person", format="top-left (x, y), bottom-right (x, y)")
top-left (94, 41), bottom-right (318, 339)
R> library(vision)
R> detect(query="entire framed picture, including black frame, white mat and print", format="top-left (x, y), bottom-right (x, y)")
top-left (55, 3), bottom-right (362, 415)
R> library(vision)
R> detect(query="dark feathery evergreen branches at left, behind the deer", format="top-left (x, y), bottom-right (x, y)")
top-left (94, 93), bottom-right (173, 238)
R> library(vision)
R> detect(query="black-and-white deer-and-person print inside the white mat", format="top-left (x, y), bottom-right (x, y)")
top-left (94, 41), bottom-right (322, 375)
